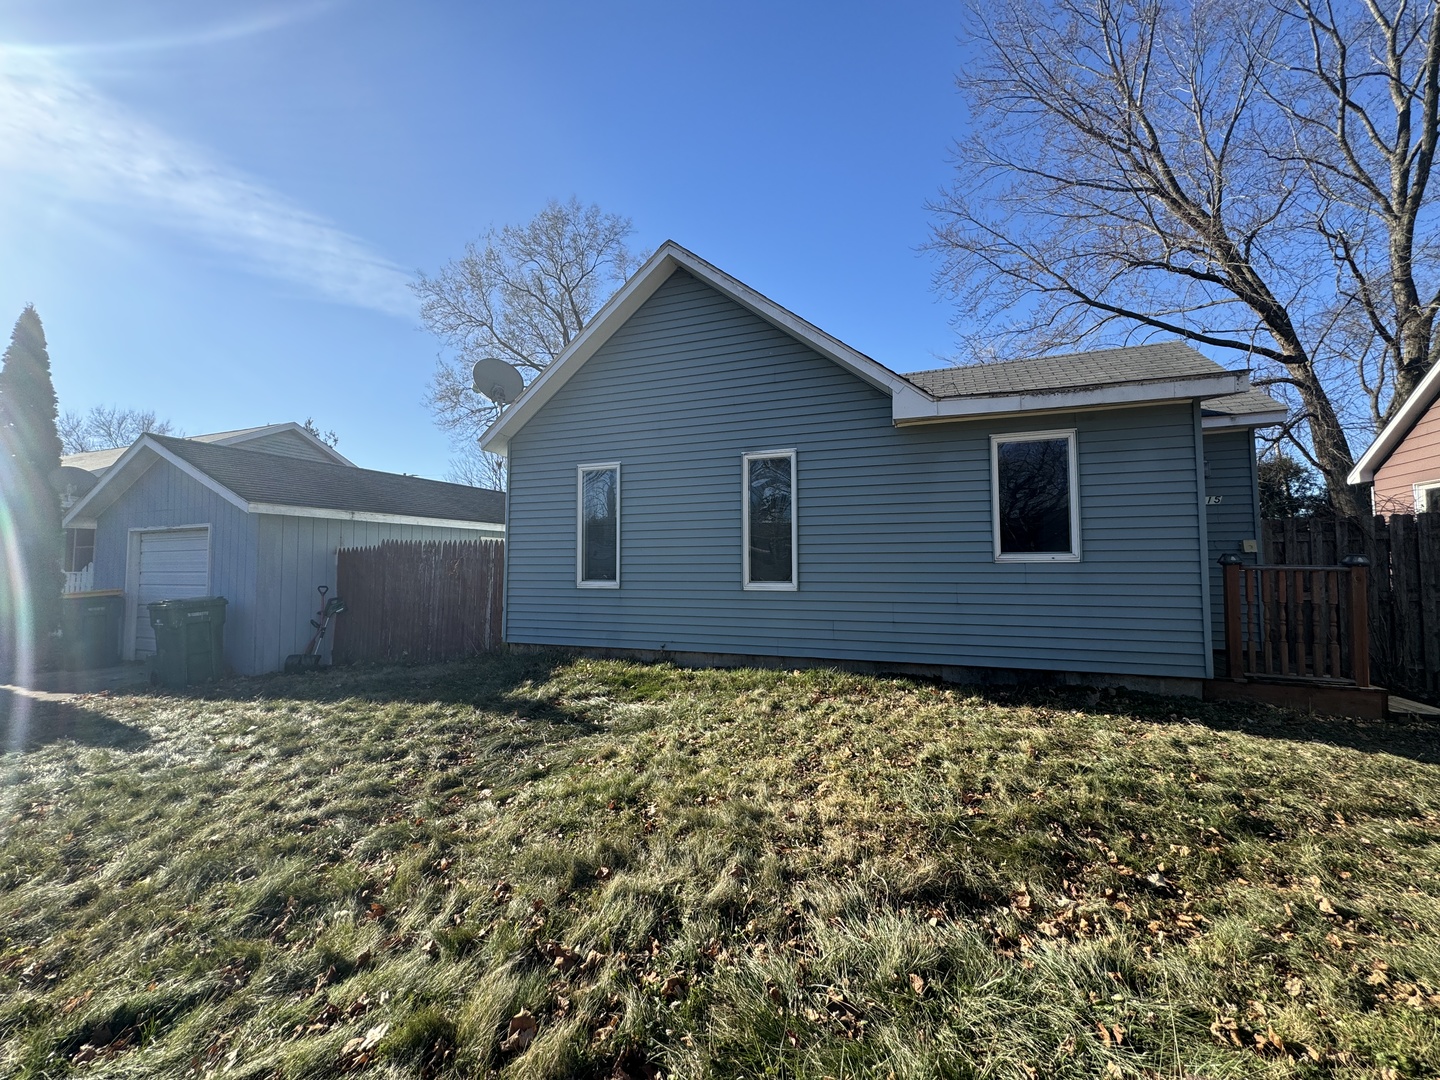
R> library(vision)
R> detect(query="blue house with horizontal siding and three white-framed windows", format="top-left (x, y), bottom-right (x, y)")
top-left (481, 243), bottom-right (1283, 693)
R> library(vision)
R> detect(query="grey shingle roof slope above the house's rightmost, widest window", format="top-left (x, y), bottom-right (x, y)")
top-left (901, 341), bottom-right (1227, 397)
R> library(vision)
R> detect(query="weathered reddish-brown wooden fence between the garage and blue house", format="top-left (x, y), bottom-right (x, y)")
top-left (333, 540), bottom-right (505, 664)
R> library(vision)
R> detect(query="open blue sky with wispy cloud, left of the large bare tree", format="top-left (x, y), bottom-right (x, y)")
top-left (0, 0), bottom-right (965, 478)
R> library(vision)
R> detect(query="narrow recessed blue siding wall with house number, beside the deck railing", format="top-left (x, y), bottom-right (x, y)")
top-left (1205, 428), bottom-right (1260, 649)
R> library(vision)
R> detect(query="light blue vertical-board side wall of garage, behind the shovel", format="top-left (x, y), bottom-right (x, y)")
top-left (253, 514), bottom-right (482, 674)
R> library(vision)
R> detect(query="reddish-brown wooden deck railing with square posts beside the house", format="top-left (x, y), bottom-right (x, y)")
top-left (1220, 554), bottom-right (1369, 687)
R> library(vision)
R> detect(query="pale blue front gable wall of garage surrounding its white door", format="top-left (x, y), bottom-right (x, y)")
top-left (92, 459), bottom-right (258, 672)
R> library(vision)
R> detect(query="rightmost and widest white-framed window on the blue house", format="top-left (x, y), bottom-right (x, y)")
top-left (991, 431), bottom-right (1080, 562)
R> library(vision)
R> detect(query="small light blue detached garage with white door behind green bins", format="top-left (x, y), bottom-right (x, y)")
top-left (65, 435), bottom-right (505, 675)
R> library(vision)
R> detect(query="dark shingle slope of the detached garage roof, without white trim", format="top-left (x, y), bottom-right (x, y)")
top-left (150, 435), bottom-right (505, 524)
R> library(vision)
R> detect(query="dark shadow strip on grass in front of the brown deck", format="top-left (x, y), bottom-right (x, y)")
top-left (976, 687), bottom-right (1440, 765)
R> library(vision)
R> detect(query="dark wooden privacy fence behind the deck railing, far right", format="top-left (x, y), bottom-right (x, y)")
top-left (1261, 514), bottom-right (1440, 698)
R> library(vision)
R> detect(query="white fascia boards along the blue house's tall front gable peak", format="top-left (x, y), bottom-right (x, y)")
top-left (480, 240), bottom-right (930, 455)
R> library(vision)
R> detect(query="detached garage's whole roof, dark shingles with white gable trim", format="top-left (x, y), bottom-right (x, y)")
top-left (65, 435), bottom-right (505, 531)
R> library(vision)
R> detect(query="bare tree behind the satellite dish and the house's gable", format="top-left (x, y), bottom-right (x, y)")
top-left (412, 196), bottom-right (644, 487)
